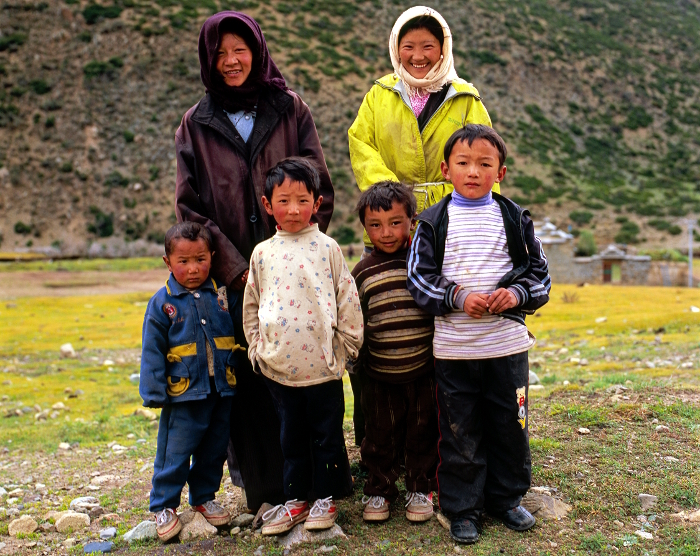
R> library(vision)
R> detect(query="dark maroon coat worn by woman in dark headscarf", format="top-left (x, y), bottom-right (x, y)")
top-left (175, 88), bottom-right (333, 285)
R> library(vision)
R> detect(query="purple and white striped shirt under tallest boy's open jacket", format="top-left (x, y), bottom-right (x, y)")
top-left (433, 193), bottom-right (535, 359)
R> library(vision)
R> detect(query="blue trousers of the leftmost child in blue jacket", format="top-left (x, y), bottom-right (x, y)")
top-left (150, 381), bottom-right (233, 512)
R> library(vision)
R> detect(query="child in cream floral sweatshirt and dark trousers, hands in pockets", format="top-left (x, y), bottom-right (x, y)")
top-left (243, 157), bottom-right (363, 535)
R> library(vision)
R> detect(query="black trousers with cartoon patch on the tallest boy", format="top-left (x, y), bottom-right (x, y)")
top-left (435, 351), bottom-right (532, 521)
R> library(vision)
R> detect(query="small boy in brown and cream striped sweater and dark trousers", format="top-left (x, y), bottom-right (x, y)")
top-left (352, 181), bottom-right (438, 522)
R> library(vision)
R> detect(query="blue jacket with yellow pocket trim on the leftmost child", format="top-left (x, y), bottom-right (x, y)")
top-left (139, 274), bottom-right (245, 407)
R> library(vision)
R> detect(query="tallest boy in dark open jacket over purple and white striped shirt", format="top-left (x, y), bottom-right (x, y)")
top-left (408, 124), bottom-right (551, 544)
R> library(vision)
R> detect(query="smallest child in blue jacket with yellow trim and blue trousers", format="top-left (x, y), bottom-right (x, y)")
top-left (139, 222), bottom-right (245, 541)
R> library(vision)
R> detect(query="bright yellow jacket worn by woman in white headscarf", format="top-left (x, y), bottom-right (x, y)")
top-left (348, 74), bottom-right (500, 245)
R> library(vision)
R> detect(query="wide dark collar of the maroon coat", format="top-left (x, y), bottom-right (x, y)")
top-left (192, 88), bottom-right (294, 165)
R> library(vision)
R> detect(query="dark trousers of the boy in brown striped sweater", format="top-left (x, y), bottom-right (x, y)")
top-left (361, 372), bottom-right (438, 502)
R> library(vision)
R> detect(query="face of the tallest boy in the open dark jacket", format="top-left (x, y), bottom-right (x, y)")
top-left (440, 139), bottom-right (506, 199)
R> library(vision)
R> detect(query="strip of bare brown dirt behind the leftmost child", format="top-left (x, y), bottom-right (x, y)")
top-left (0, 268), bottom-right (168, 299)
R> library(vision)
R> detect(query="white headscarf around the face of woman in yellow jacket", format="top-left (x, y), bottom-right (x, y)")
top-left (389, 6), bottom-right (457, 97)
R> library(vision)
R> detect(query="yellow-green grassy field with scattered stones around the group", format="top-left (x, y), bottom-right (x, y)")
top-left (0, 284), bottom-right (700, 555)
